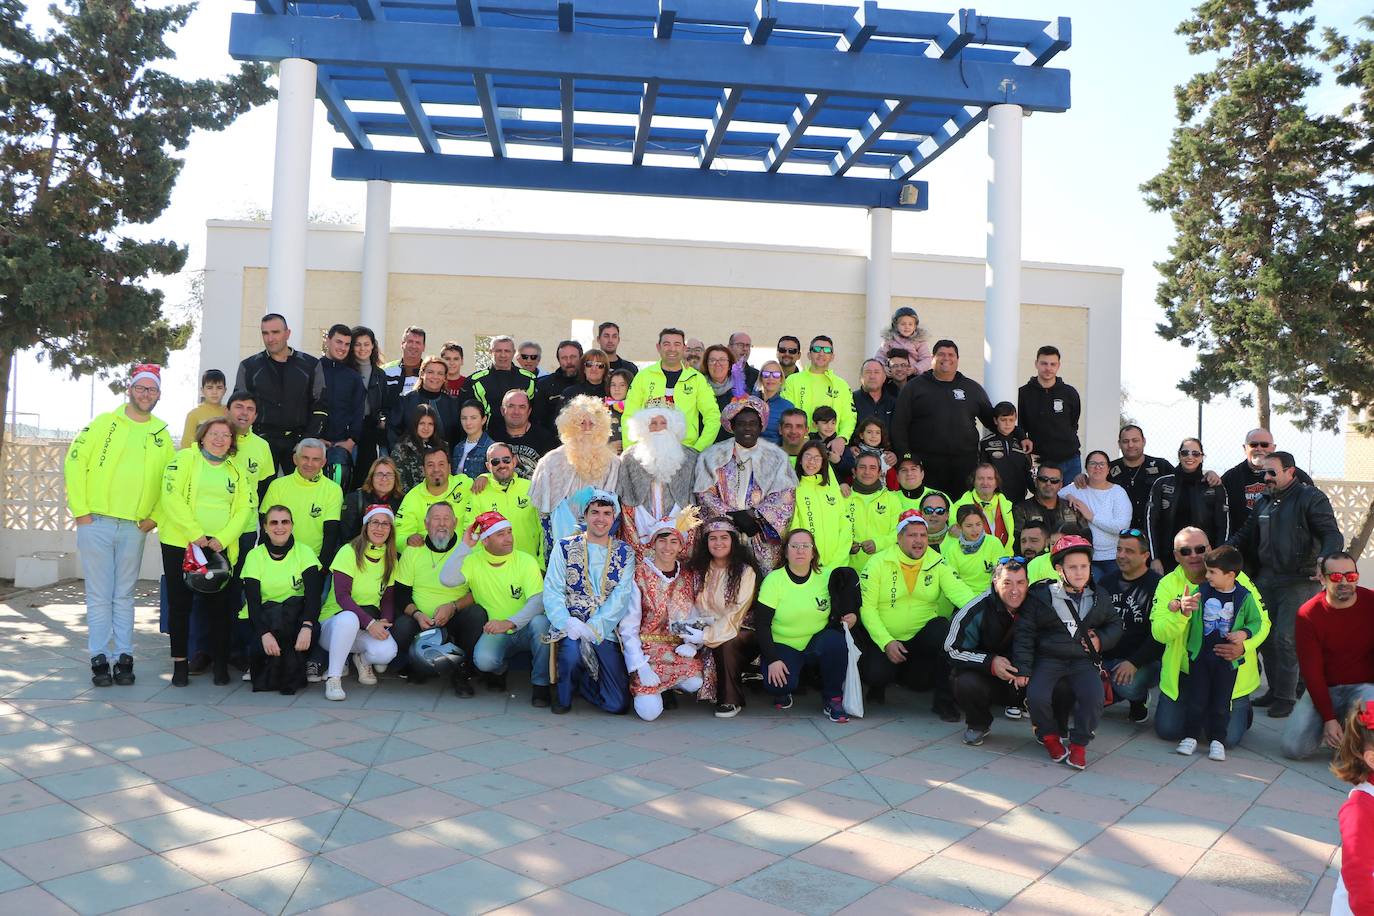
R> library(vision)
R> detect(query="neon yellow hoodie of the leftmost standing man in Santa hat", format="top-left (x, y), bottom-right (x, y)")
top-left (62, 407), bottom-right (176, 522)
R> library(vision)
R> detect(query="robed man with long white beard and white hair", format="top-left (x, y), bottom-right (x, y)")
top-left (616, 398), bottom-right (697, 553)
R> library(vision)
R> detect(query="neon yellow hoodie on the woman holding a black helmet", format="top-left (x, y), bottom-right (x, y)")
top-left (157, 445), bottom-right (257, 563)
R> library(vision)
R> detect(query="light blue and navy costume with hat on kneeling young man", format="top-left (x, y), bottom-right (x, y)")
top-left (544, 490), bottom-right (635, 714)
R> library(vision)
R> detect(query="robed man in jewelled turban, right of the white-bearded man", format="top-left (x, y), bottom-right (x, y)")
top-left (695, 396), bottom-right (797, 575)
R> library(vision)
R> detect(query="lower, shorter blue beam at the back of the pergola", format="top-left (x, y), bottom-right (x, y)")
top-left (333, 150), bottom-right (929, 210)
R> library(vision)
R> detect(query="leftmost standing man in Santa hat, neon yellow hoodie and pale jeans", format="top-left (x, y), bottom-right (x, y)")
top-left (62, 365), bottom-right (176, 687)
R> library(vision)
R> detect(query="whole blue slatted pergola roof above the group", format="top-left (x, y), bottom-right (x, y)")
top-left (229, 0), bottom-right (1070, 210)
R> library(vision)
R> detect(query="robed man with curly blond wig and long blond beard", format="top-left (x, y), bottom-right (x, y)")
top-left (529, 394), bottom-right (620, 556)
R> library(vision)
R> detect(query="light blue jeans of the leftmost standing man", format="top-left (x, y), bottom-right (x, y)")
top-left (77, 515), bottom-right (146, 658)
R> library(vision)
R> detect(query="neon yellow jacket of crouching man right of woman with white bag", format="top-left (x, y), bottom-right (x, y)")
top-left (859, 544), bottom-right (977, 648)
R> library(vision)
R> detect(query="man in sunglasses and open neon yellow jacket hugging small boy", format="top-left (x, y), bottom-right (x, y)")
top-left (1150, 527), bottom-right (1270, 747)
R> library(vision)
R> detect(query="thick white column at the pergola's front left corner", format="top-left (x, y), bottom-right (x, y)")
top-left (267, 58), bottom-right (316, 341)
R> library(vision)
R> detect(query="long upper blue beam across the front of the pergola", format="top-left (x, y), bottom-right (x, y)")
top-left (229, 12), bottom-right (1069, 111)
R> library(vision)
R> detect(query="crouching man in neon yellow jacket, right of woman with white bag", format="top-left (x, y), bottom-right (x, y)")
top-left (859, 509), bottom-right (976, 722)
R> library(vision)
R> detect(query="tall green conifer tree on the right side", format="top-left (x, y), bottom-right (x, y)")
top-left (1142, 0), bottom-right (1374, 428)
